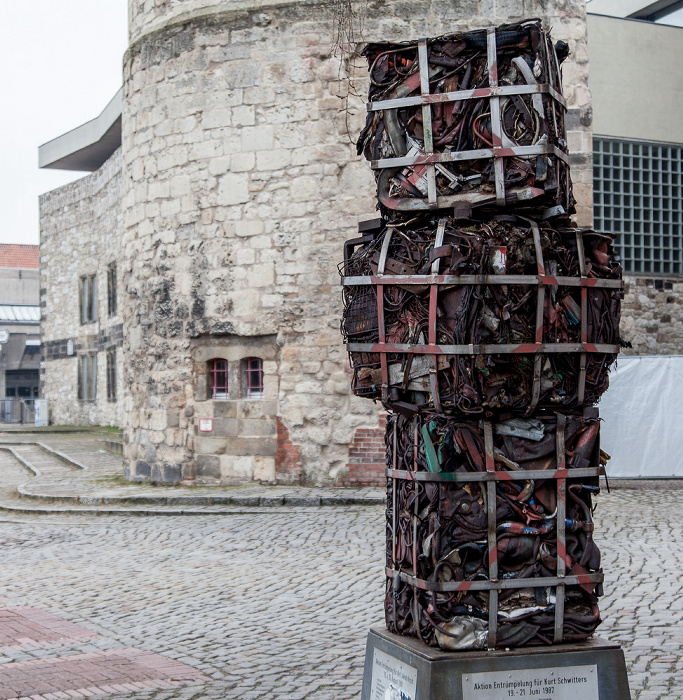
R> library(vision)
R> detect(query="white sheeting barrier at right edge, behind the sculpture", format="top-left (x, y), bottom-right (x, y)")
top-left (600, 355), bottom-right (683, 479)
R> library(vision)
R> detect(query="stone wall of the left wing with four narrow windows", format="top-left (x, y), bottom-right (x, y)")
top-left (40, 151), bottom-right (124, 426)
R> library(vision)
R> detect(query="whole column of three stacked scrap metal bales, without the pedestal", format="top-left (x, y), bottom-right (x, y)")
top-left (340, 20), bottom-right (623, 650)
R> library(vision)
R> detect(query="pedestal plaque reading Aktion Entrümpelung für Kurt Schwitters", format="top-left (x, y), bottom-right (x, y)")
top-left (462, 666), bottom-right (600, 700)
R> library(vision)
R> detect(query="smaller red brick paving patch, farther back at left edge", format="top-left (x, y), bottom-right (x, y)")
top-left (0, 607), bottom-right (99, 656)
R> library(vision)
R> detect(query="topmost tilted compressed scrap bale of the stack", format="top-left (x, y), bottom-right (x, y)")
top-left (357, 20), bottom-right (575, 218)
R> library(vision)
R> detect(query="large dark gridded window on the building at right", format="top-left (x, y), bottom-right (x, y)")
top-left (593, 137), bottom-right (683, 275)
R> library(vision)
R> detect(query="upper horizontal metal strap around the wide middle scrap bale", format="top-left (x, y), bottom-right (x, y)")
top-left (342, 270), bottom-right (624, 289)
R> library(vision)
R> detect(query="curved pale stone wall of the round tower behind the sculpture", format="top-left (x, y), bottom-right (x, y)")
top-left (123, 0), bottom-right (591, 483)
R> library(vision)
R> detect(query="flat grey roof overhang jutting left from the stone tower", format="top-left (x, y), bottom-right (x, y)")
top-left (38, 88), bottom-right (123, 172)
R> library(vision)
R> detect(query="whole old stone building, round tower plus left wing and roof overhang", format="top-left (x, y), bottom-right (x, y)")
top-left (40, 0), bottom-right (676, 484)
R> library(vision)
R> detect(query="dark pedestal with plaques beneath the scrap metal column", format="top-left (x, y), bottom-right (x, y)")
top-left (361, 625), bottom-right (631, 700)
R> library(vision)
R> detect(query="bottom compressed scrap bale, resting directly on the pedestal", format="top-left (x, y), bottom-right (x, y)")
top-left (385, 409), bottom-right (606, 650)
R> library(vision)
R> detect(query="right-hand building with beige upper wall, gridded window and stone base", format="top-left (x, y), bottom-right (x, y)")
top-left (588, 13), bottom-right (683, 355)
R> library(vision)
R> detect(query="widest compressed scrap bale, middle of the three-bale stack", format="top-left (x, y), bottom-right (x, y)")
top-left (342, 215), bottom-right (623, 414)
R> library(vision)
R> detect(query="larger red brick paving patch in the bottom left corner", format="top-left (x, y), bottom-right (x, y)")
top-left (0, 648), bottom-right (210, 700)
